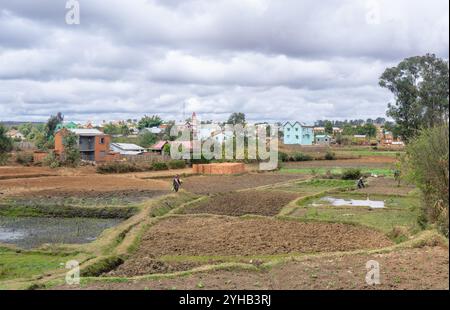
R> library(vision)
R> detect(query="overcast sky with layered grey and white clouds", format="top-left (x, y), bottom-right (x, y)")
top-left (0, 0), bottom-right (449, 123)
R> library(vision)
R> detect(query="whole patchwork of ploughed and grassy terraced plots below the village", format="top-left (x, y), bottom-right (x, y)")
top-left (0, 160), bottom-right (448, 289)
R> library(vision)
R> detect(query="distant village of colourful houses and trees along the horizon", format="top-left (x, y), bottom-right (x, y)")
top-left (0, 112), bottom-right (404, 165)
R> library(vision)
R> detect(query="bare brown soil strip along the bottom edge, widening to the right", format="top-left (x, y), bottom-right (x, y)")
top-left (59, 247), bottom-right (449, 290)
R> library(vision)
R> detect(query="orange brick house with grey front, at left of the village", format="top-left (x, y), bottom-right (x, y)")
top-left (55, 128), bottom-right (111, 162)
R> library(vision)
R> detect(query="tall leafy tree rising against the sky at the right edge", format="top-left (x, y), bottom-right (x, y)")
top-left (380, 54), bottom-right (449, 141)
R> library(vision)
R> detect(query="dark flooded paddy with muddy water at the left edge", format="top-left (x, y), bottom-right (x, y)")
top-left (0, 216), bottom-right (122, 249)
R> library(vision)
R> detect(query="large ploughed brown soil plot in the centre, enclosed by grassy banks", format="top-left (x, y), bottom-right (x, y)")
top-left (112, 216), bottom-right (392, 276)
